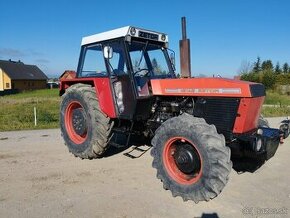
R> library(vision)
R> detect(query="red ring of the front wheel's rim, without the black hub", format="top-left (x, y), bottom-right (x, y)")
top-left (163, 137), bottom-right (202, 185)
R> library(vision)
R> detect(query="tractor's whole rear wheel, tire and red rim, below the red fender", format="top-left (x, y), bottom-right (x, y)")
top-left (60, 84), bottom-right (114, 159)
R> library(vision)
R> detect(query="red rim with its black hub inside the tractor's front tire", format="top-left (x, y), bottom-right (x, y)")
top-left (163, 137), bottom-right (202, 185)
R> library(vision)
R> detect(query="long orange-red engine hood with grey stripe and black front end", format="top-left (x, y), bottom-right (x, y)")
top-left (151, 78), bottom-right (265, 97)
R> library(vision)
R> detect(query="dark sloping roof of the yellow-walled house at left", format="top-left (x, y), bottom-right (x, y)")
top-left (0, 60), bottom-right (47, 80)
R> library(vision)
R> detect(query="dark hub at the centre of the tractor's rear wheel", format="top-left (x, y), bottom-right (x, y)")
top-left (72, 108), bottom-right (87, 135)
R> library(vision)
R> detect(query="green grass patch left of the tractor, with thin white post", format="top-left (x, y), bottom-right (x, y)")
top-left (0, 89), bottom-right (60, 131)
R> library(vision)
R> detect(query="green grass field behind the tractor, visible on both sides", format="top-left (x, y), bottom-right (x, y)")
top-left (0, 89), bottom-right (290, 131)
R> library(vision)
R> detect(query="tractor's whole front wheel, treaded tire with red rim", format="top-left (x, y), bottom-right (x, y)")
top-left (151, 114), bottom-right (232, 203)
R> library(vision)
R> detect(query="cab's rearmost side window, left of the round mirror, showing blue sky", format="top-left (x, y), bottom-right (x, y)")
top-left (81, 44), bottom-right (107, 77)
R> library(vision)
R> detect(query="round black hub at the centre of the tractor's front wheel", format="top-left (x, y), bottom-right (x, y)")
top-left (173, 144), bottom-right (201, 175)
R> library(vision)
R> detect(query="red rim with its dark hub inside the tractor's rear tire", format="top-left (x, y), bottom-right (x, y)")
top-left (65, 101), bottom-right (87, 144)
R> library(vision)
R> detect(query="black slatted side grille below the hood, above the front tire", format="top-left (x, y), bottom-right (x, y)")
top-left (194, 98), bottom-right (240, 139)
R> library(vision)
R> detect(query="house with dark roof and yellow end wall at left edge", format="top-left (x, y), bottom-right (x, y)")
top-left (0, 60), bottom-right (47, 93)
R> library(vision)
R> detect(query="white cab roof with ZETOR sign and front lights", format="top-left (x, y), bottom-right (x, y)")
top-left (82, 26), bottom-right (168, 45)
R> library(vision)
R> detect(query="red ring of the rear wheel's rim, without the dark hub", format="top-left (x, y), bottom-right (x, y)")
top-left (65, 101), bottom-right (87, 144)
